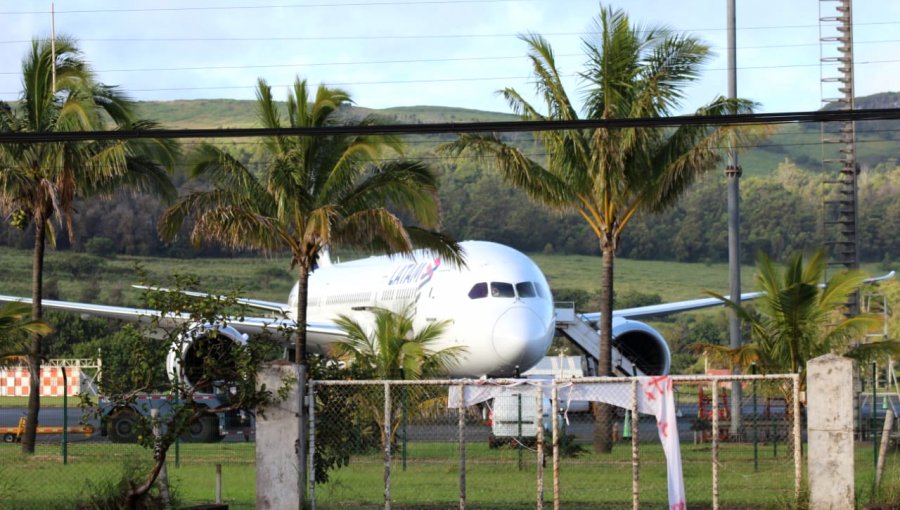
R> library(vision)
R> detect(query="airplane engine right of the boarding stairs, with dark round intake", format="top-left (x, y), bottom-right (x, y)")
top-left (612, 319), bottom-right (672, 375)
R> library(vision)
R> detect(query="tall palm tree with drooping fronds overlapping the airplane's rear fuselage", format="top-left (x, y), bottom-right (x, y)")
top-left (160, 78), bottom-right (461, 366)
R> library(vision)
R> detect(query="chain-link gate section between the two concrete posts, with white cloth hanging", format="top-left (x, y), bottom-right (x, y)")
top-left (310, 376), bottom-right (802, 508)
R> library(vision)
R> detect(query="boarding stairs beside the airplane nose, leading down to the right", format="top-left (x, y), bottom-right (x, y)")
top-left (555, 301), bottom-right (646, 377)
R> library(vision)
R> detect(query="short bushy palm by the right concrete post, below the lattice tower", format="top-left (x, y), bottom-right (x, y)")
top-left (699, 250), bottom-right (888, 397)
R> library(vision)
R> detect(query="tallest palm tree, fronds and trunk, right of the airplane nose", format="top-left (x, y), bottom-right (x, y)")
top-left (443, 3), bottom-right (753, 451)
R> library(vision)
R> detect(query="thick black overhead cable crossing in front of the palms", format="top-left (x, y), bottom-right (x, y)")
top-left (0, 108), bottom-right (900, 143)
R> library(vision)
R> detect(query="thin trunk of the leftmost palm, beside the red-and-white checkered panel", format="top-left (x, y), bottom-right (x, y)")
top-left (22, 213), bottom-right (46, 454)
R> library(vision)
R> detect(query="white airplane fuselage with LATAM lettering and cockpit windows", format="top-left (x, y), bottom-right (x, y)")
top-left (288, 241), bottom-right (555, 377)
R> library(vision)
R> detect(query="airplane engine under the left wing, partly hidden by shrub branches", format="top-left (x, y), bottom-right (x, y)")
top-left (166, 324), bottom-right (249, 393)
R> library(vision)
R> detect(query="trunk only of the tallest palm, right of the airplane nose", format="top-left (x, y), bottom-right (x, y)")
top-left (594, 242), bottom-right (615, 453)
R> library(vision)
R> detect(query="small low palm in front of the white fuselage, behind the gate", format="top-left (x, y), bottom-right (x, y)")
top-left (333, 306), bottom-right (466, 446)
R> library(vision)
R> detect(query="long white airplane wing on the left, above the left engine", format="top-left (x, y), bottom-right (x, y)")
top-left (0, 295), bottom-right (346, 343)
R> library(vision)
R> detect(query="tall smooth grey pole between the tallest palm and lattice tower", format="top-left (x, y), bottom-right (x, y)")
top-left (713, 0), bottom-right (741, 436)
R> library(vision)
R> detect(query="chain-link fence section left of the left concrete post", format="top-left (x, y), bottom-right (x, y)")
top-left (0, 386), bottom-right (256, 510)
